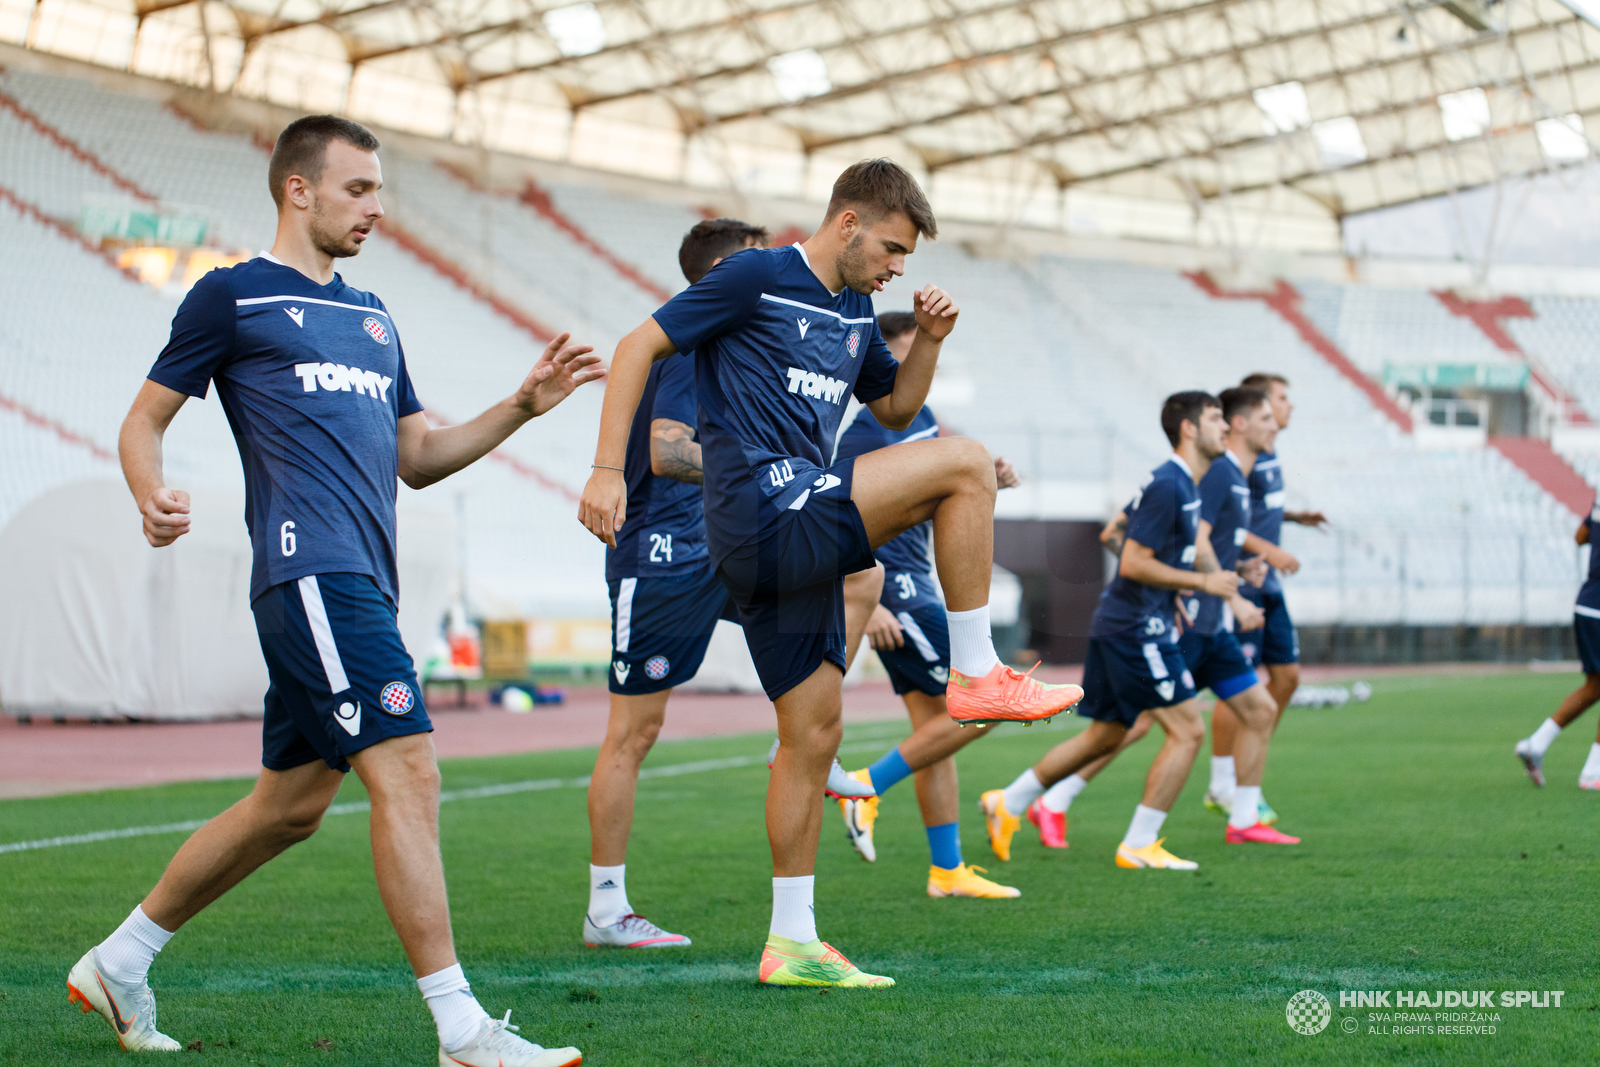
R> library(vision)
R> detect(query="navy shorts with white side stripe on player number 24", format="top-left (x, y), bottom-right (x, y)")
top-left (608, 563), bottom-right (739, 696)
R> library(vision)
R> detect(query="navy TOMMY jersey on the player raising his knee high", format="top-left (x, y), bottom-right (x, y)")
top-left (654, 245), bottom-right (898, 563)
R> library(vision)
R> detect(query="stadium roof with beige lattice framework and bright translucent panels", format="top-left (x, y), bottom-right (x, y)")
top-left (9, 0), bottom-right (1600, 243)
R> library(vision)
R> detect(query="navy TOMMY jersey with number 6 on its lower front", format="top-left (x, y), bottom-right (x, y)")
top-left (149, 256), bottom-right (422, 601)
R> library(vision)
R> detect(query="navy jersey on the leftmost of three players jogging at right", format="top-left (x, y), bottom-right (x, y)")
top-left (1090, 453), bottom-right (1200, 641)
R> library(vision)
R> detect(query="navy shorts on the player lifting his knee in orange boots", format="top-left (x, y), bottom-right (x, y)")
top-left (717, 458), bottom-right (878, 701)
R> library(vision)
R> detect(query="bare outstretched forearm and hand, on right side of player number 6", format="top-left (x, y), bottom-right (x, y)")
top-left (397, 333), bottom-right (601, 490)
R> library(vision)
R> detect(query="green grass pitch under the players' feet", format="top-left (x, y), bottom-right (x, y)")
top-left (0, 673), bottom-right (1600, 1067)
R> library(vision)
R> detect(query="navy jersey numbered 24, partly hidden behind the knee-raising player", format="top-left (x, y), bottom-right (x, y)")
top-left (605, 354), bottom-right (706, 582)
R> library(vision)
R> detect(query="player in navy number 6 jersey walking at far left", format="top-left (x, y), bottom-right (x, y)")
top-left (67, 115), bottom-right (605, 1067)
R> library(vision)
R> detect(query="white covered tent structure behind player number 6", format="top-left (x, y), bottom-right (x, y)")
top-left (0, 478), bottom-right (453, 720)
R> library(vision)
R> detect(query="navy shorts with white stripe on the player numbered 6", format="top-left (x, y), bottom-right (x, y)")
top-left (251, 574), bottom-right (434, 771)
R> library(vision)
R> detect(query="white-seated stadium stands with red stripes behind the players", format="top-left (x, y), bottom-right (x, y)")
top-left (0, 70), bottom-right (1600, 624)
